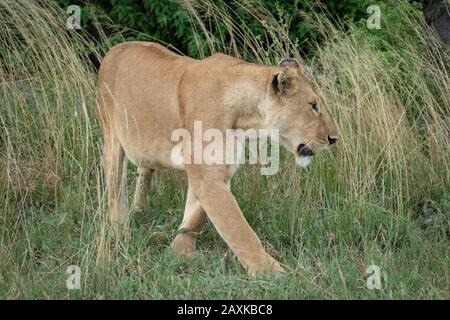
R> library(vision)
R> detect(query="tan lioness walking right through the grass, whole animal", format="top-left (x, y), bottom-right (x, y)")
top-left (98, 42), bottom-right (337, 274)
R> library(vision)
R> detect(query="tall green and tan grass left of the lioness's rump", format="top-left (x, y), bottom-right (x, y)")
top-left (0, 0), bottom-right (109, 297)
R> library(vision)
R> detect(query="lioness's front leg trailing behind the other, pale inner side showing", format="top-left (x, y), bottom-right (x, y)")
top-left (171, 188), bottom-right (206, 258)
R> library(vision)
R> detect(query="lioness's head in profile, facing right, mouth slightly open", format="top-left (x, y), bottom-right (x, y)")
top-left (265, 59), bottom-right (337, 167)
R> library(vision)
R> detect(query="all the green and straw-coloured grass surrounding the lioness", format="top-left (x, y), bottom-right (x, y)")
top-left (0, 0), bottom-right (450, 299)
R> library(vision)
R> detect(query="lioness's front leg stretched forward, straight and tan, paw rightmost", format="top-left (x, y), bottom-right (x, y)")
top-left (187, 166), bottom-right (283, 275)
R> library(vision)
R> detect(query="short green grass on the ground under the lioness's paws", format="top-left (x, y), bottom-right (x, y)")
top-left (0, 170), bottom-right (449, 299)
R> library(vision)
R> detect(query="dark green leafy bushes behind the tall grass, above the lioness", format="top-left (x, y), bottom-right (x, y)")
top-left (57, 0), bottom-right (388, 58)
